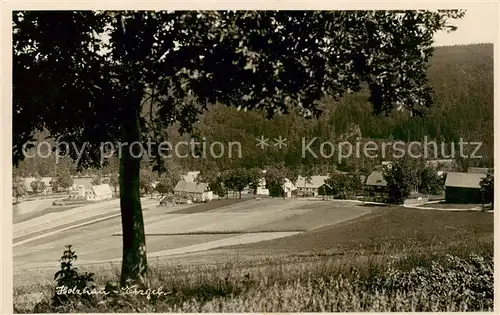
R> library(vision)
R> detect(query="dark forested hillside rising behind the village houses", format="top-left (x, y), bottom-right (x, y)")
top-left (14, 44), bottom-right (493, 176)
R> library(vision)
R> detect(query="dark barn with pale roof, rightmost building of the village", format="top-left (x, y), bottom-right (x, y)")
top-left (444, 172), bottom-right (486, 203)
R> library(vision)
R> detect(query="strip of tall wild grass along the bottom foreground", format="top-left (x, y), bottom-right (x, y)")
top-left (15, 254), bottom-right (493, 313)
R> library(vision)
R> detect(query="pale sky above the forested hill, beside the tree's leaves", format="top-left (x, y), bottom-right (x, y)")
top-left (434, 4), bottom-right (498, 46)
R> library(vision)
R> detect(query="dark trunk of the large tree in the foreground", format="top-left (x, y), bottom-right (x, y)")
top-left (120, 91), bottom-right (147, 286)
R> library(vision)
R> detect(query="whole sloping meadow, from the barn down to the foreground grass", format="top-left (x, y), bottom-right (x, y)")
top-left (14, 207), bottom-right (493, 313)
